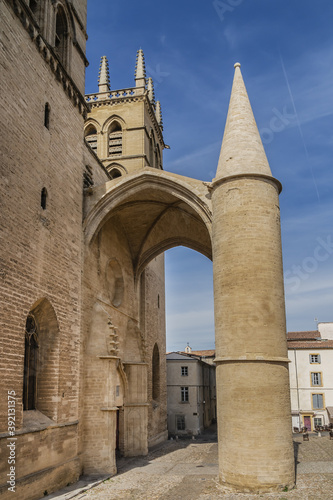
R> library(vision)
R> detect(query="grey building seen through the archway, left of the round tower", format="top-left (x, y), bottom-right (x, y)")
top-left (166, 351), bottom-right (216, 435)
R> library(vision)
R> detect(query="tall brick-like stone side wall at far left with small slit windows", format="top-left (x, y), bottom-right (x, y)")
top-left (0, 1), bottom-right (84, 499)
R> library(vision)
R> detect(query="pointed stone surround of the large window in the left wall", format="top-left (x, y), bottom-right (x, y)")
top-left (23, 298), bottom-right (59, 421)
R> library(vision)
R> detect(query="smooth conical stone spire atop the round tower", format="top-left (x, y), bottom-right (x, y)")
top-left (216, 63), bottom-right (272, 179)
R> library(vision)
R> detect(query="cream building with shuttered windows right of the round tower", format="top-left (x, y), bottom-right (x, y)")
top-left (288, 323), bottom-right (333, 430)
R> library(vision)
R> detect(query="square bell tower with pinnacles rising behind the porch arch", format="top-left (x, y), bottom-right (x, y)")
top-left (85, 49), bottom-right (166, 178)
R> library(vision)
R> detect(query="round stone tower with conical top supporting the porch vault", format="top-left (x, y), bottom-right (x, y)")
top-left (212, 63), bottom-right (295, 492)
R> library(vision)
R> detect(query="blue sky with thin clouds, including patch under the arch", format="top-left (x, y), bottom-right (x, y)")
top-left (86, 0), bottom-right (333, 350)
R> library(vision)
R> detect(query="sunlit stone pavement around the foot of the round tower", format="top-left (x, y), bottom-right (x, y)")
top-left (53, 433), bottom-right (333, 500)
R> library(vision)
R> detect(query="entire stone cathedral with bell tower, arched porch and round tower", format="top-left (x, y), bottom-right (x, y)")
top-left (0, 0), bottom-right (294, 500)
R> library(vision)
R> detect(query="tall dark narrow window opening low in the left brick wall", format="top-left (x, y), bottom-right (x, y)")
top-left (23, 314), bottom-right (38, 410)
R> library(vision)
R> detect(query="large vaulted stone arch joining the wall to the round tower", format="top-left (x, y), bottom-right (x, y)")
top-left (84, 169), bottom-right (212, 280)
